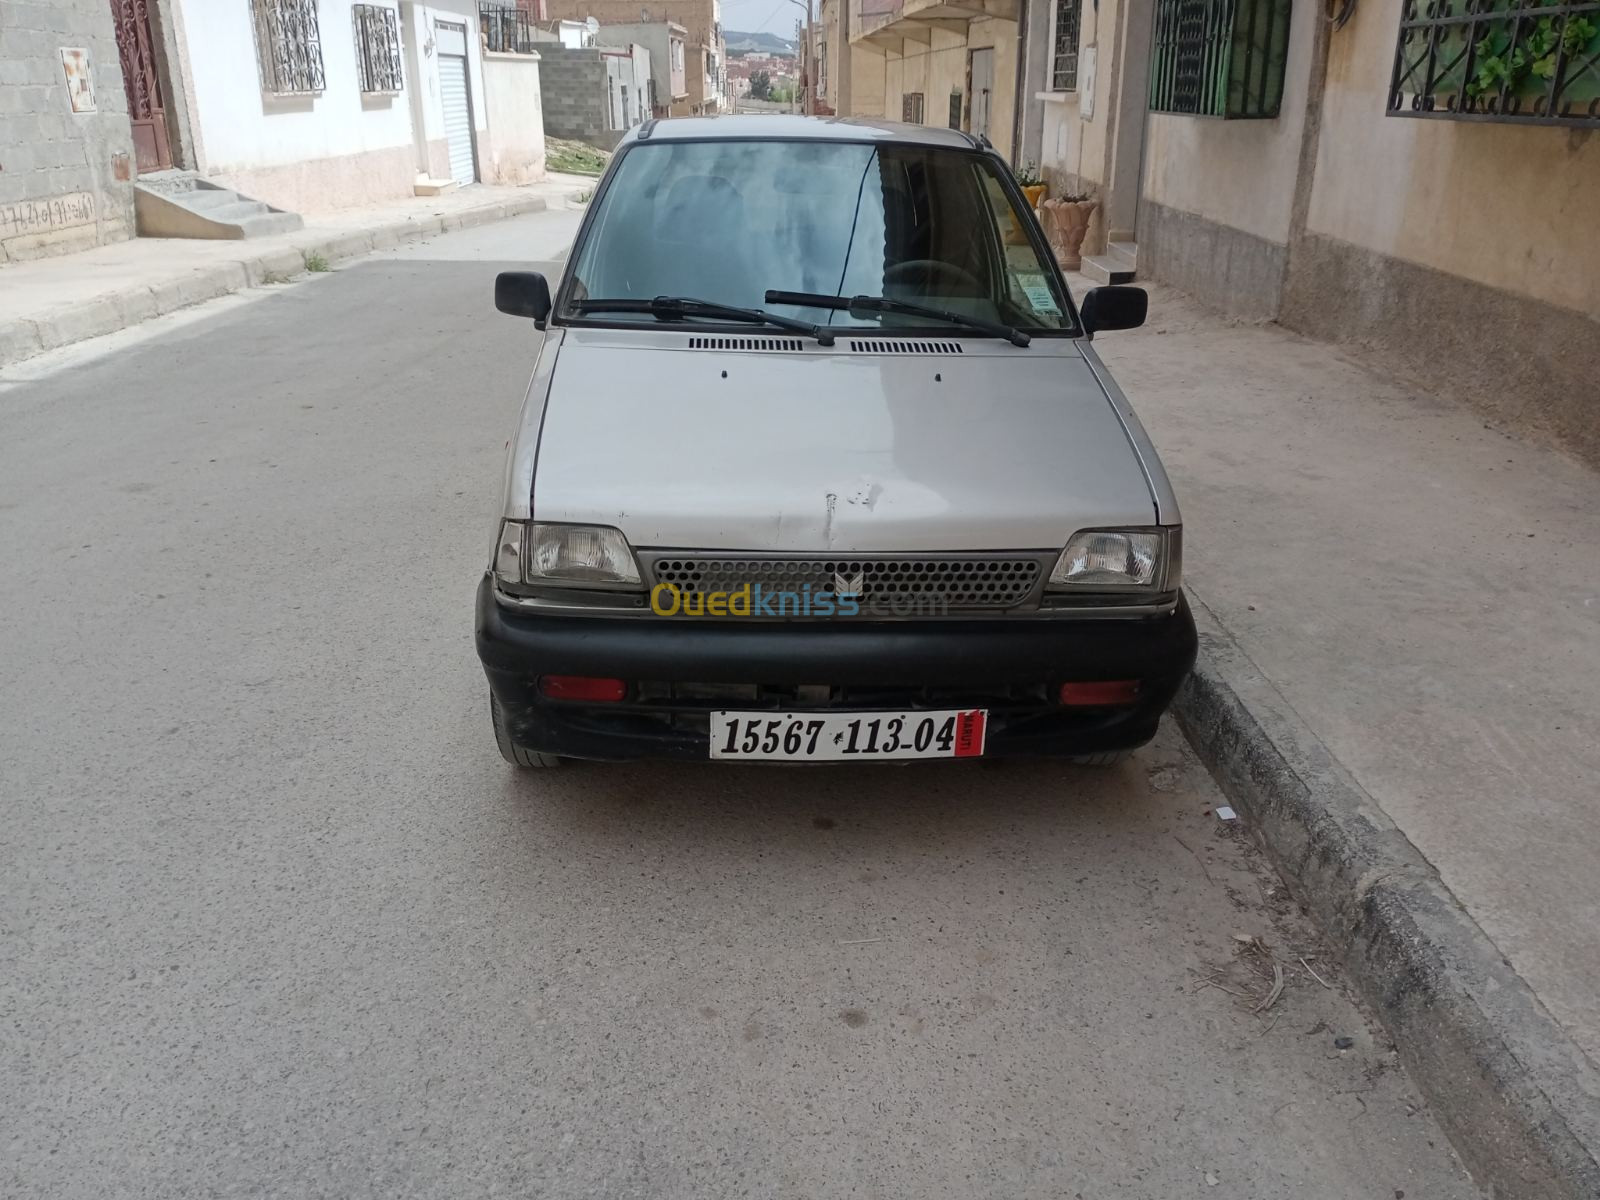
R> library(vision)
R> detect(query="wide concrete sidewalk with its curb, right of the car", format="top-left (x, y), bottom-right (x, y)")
top-left (1074, 280), bottom-right (1600, 1195)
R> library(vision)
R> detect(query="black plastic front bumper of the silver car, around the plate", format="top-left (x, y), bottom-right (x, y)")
top-left (477, 576), bottom-right (1195, 760)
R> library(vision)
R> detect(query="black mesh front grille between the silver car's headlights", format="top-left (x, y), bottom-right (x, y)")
top-left (642, 550), bottom-right (1048, 616)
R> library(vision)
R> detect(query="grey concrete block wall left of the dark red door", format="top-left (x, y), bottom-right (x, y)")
top-left (0, 0), bottom-right (134, 262)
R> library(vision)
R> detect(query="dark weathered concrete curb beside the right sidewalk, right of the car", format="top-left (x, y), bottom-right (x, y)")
top-left (1173, 594), bottom-right (1600, 1200)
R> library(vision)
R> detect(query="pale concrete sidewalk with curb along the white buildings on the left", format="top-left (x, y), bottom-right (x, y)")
top-left (0, 173), bottom-right (595, 366)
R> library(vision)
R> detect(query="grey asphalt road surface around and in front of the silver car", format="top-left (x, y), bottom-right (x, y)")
top-left (0, 213), bottom-right (1477, 1200)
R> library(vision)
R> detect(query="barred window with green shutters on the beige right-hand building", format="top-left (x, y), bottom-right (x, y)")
top-left (1150, 0), bottom-right (1293, 117)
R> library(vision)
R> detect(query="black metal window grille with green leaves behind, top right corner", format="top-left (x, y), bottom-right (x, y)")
top-left (1389, 0), bottom-right (1600, 126)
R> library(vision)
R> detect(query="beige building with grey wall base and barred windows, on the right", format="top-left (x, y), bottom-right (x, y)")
top-left (1019, 0), bottom-right (1600, 462)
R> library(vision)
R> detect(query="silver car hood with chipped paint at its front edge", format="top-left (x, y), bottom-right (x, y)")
top-left (533, 331), bottom-right (1155, 552)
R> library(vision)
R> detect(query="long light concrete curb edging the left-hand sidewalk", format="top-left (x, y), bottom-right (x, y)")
top-left (0, 195), bottom-right (549, 366)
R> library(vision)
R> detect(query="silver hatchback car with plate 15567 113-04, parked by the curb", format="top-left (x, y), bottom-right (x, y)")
top-left (477, 115), bottom-right (1195, 766)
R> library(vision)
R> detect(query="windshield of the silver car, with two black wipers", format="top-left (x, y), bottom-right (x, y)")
top-left (562, 139), bottom-right (1075, 334)
